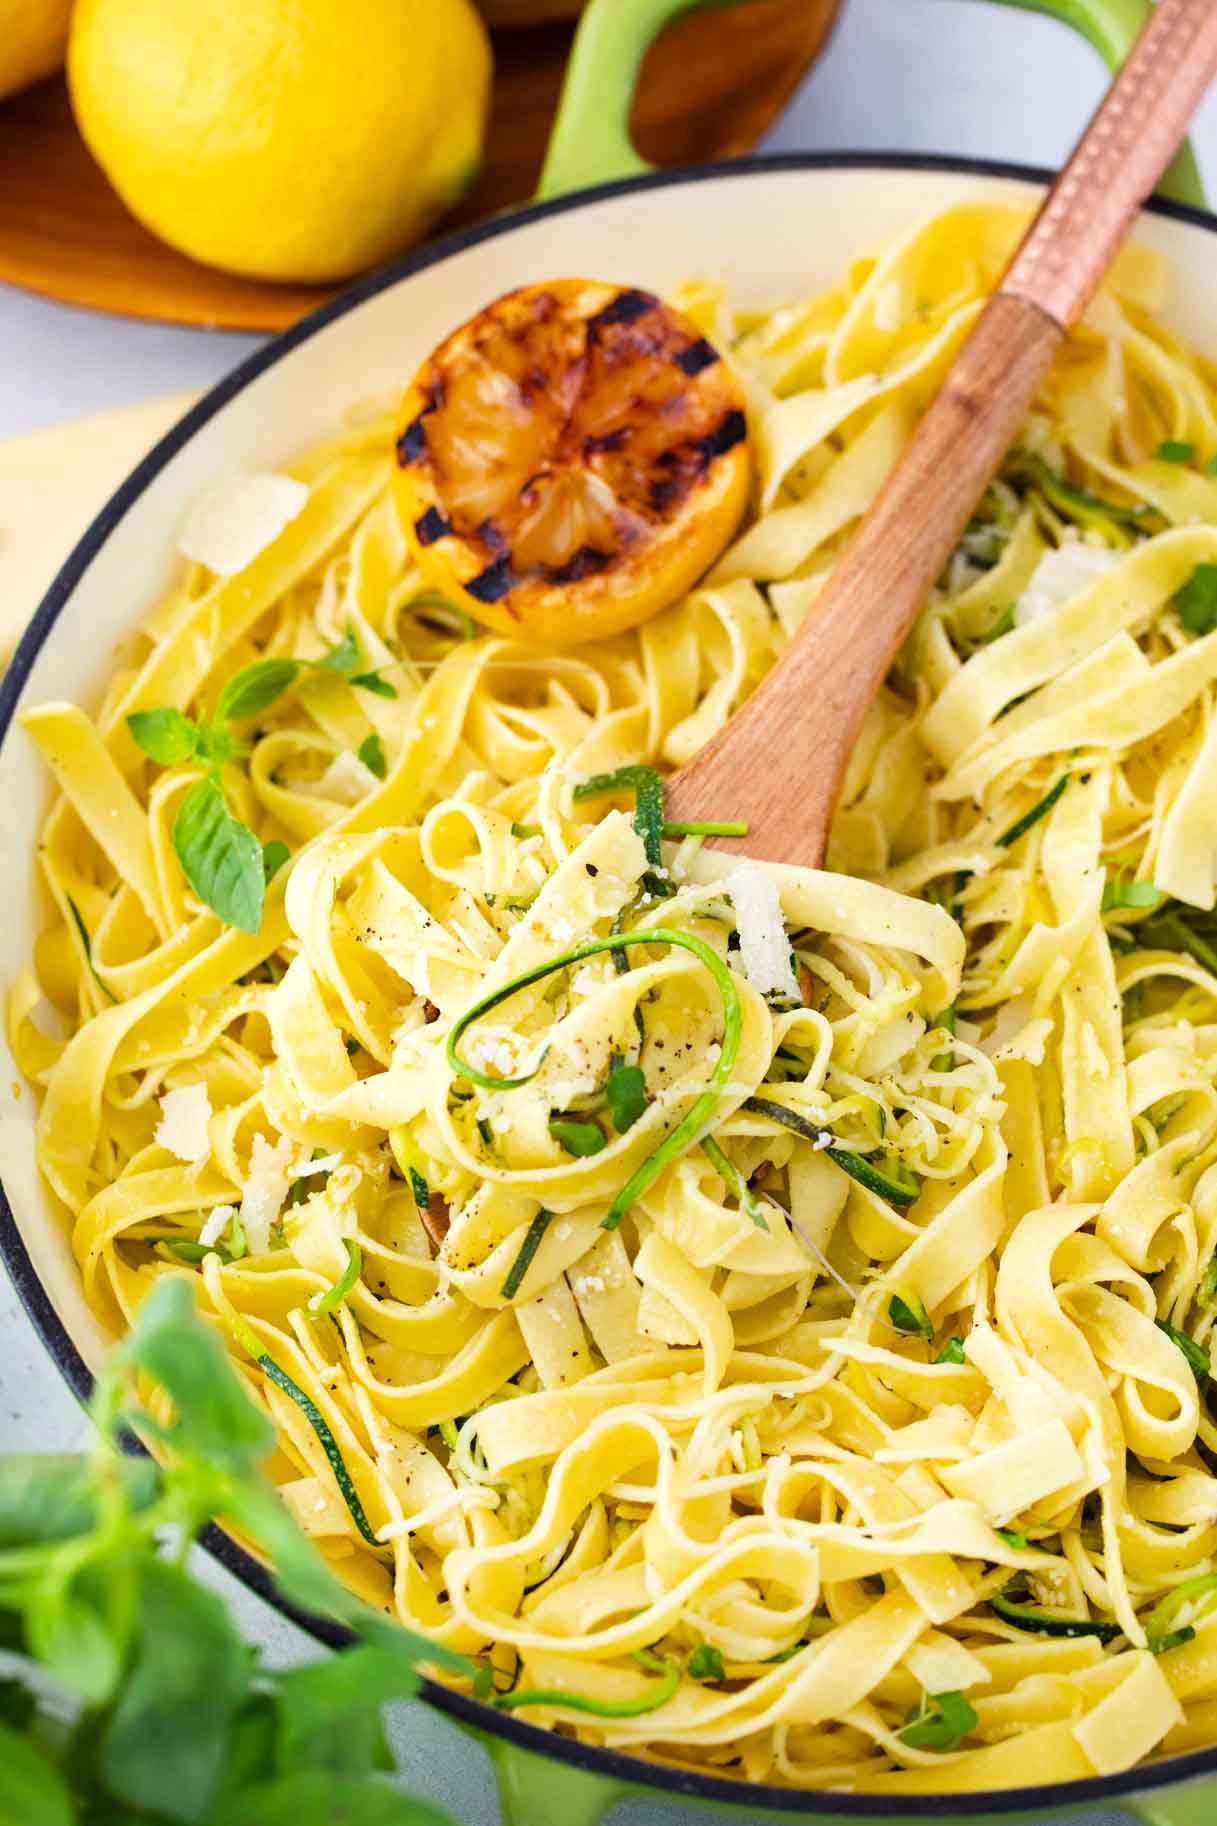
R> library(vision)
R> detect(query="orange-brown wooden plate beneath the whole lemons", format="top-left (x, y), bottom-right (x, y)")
top-left (0, 0), bottom-right (839, 331)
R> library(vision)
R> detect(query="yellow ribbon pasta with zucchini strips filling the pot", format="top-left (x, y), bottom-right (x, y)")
top-left (9, 205), bottom-right (1217, 1793)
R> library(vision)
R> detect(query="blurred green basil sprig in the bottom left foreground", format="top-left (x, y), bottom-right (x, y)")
top-left (0, 1276), bottom-right (465, 1826)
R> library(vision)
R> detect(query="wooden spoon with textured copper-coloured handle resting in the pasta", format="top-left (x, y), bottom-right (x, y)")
top-left (667, 0), bottom-right (1217, 866)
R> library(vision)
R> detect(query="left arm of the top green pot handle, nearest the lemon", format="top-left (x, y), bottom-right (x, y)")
top-left (537, 0), bottom-right (760, 197)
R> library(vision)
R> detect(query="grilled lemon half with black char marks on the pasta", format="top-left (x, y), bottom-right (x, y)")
top-left (395, 279), bottom-right (751, 646)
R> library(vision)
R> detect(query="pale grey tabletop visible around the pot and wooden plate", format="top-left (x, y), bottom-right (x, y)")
top-left (0, 0), bottom-right (1217, 1826)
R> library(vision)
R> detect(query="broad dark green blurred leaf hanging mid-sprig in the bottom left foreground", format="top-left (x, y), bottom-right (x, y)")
top-left (97, 1559), bottom-right (250, 1822)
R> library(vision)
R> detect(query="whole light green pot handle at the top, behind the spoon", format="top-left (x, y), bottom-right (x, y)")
top-left (537, 0), bottom-right (1206, 208)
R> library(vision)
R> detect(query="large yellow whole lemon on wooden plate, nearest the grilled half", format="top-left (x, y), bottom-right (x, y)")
top-left (68, 0), bottom-right (490, 281)
